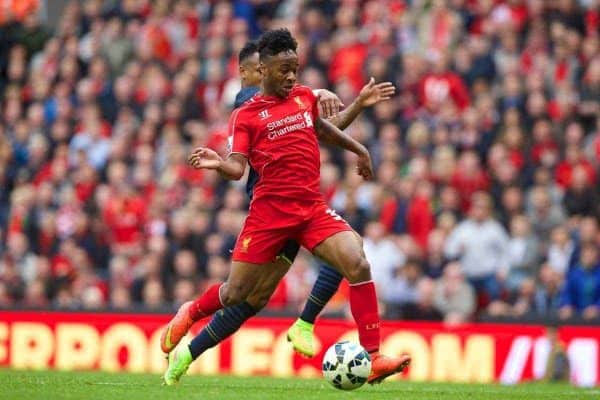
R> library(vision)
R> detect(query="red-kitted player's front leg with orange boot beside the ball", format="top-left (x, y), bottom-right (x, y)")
top-left (313, 231), bottom-right (410, 384)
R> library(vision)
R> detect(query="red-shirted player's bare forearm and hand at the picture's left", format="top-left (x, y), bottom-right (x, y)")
top-left (188, 147), bottom-right (248, 181)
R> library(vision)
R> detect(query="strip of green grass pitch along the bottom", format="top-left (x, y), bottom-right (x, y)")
top-left (0, 369), bottom-right (600, 400)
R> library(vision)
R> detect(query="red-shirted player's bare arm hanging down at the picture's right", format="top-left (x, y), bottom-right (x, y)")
top-left (315, 118), bottom-right (373, 180)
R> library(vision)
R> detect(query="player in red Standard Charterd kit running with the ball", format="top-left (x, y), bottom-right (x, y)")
top-left (164, 29), bottom-right (410, 385)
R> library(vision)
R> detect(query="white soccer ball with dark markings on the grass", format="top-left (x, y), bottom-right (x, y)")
top-left (323, 341), bottom-right (371, 390)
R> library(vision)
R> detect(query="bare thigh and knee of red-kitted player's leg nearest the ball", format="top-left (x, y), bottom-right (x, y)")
top-left (312, 231), bottom-right (371, 283)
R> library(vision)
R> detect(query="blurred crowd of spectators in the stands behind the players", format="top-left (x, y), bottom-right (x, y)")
top-left (0, 0), bottom-right (600, 322)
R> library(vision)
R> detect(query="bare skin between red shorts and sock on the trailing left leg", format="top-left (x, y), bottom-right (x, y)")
top-left (221, 261), bottom-right (265, 306)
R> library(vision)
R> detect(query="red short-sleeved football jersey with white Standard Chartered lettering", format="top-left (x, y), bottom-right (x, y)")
top-left (229, 85), bottom-right (322, 201)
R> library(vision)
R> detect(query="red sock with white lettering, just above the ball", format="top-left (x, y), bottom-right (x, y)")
top-left (350, 281), bottom-right (379, 353)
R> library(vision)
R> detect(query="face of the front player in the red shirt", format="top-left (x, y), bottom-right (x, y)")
top-left (261, 50), bottom-right (298, 98)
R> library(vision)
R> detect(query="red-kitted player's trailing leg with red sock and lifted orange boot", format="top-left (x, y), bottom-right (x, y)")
top-left (160, 261), bottom-right (262, 353)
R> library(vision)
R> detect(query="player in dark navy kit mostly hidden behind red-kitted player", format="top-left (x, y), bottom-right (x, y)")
top-left (160, 42), bottom-right (395, 358)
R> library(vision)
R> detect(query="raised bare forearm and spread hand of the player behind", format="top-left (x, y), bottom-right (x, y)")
top-left (328, 78), bottom-right (396, 129)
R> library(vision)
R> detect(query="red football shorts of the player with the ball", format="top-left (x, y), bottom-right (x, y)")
top-left (232, 198), bottom-right (352, 264)
